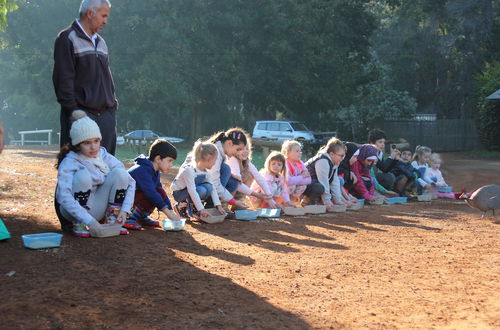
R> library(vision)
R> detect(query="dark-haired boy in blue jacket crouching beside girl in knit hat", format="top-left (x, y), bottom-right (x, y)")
top-left (123, 139), bottom-right (180, 230)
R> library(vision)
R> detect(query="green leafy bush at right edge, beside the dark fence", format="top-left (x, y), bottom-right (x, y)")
top-left (476, 62), bottom-right (500, 151)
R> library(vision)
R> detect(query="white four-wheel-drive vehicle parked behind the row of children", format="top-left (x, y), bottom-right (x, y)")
top-left (252, 120), bottom-right (336, 141)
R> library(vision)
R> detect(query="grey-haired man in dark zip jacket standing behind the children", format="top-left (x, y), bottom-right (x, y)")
top-left (52, 0), bottom-right (118, 155)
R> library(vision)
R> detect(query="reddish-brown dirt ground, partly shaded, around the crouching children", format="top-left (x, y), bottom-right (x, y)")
top-left (0, 148), bottom-right (500, 329)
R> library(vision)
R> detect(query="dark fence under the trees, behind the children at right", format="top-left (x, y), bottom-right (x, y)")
top-left (371, 119), bottom-right (480, 152)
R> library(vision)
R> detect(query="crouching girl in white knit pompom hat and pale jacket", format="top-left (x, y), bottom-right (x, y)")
top-left (55, 110), bottom-right (135, 237)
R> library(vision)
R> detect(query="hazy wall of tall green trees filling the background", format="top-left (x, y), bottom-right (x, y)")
top-left (0, 0), bottom-right (500, 145)
